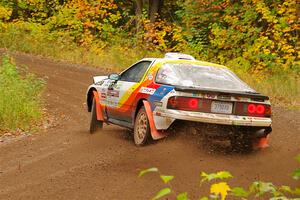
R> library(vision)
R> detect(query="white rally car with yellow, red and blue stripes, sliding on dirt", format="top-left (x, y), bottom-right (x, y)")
top-left (87, 53), bottom-right (272, 148)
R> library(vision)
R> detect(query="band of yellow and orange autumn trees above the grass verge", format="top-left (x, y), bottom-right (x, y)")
top-left (0, 0), bottom-right (300, 74)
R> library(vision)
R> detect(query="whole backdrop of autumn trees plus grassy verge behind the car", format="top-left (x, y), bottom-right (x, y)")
top-left (0, 0), bottom-right (300, 108)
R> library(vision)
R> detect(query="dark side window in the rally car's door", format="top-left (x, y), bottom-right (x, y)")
top-left (120, 61), bottom-right (151, 82)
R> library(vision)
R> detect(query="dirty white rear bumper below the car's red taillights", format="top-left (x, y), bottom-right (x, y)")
top-left (158, 109), bottom-right (272, 127)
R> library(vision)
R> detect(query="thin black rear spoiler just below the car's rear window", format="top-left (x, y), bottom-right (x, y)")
top-left (174, 86), bottom-right (269, 101)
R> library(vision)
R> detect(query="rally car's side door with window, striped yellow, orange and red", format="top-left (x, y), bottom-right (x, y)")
top-left (106, 60), bottom-right (152, 122)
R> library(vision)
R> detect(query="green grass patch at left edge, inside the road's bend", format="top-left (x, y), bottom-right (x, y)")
top-left (0, 55), bottom-right (44, 135)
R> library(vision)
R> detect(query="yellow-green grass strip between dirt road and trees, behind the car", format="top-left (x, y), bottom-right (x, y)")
top-left (0, 22), bottom-right (300, 110)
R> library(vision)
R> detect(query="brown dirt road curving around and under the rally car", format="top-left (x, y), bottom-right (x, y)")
top-left (0, 54), bottom-right (300, 200)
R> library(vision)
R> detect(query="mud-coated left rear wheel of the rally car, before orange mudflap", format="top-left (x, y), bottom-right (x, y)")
top-left (133, 107), bottom-right (150, 146)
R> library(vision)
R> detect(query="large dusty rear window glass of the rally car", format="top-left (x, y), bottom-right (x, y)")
top-left (156, 63), bottom-right (255, 92)
